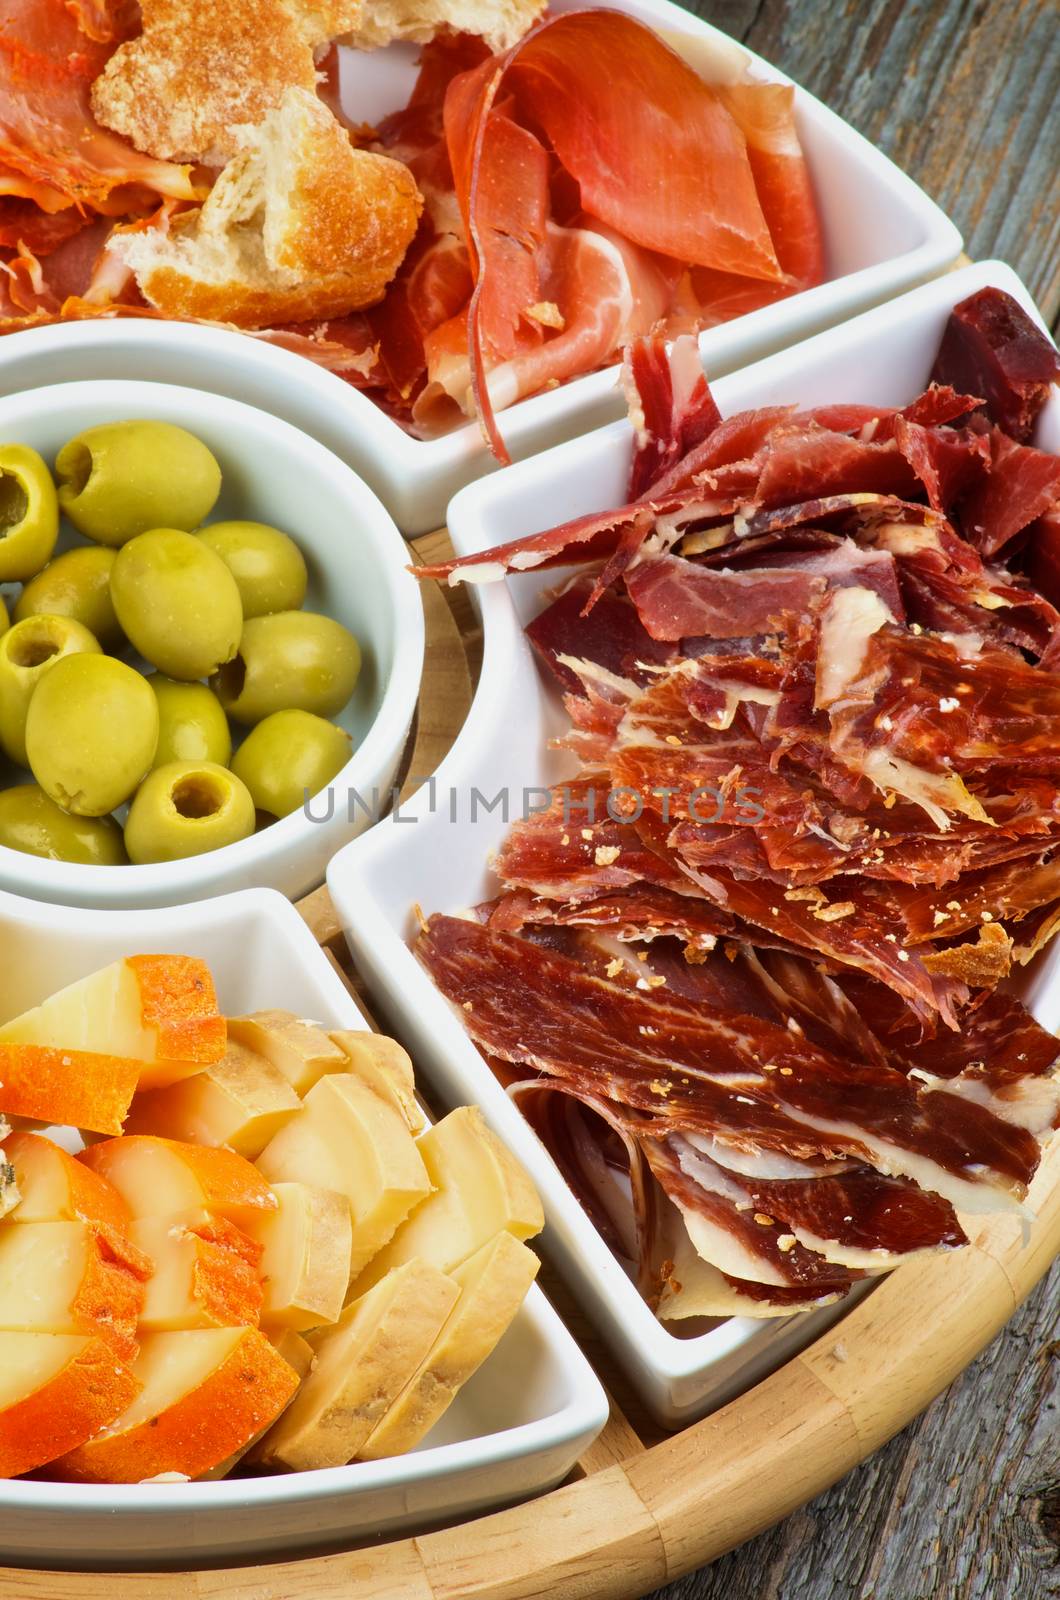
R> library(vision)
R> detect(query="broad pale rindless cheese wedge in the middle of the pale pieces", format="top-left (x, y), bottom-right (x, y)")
top-left (258, 1072), bottom-right (431, 1275)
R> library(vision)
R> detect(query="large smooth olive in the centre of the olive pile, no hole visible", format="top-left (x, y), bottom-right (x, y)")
top-left (110, 528), bottom-right (243, 683)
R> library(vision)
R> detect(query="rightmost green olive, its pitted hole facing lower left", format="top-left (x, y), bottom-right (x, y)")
top-left (213, 611), bottom-right (360, 725)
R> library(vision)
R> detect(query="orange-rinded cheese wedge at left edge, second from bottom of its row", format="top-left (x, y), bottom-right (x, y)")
top-left (0, 1222), bottom-right (151, 1362)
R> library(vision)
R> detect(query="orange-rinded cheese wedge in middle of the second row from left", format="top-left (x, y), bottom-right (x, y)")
top-left (130, 1211), bottom-right (261, 1334)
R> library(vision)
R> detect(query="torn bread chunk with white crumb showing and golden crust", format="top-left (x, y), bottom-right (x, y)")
top-left (109, 88), bottom-right (423, 328)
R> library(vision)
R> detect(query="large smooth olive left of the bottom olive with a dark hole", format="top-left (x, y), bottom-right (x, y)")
top-left (26, 656), bottom-right (159, 816)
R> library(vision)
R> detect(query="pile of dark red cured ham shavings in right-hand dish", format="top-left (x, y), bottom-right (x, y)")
top-left (416, 290), bottom-right (1060, 1318)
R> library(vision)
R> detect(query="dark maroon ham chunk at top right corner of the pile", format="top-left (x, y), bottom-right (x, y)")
top-left (932, 288), bottom-right (1060, 443)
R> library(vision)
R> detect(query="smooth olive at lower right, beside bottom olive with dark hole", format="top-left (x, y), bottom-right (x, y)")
top-left (232, 710), bottom-right (352, 816)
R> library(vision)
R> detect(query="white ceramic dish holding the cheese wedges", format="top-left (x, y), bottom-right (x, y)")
top-left (0, 890), bottom-right (607, 1568)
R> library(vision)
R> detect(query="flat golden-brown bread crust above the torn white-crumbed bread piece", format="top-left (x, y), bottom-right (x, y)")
top-left (91, 0), bottom-right (363, 166)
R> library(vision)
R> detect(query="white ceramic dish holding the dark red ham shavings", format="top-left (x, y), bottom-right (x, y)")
top-left (328, 262), bottom-right (1060, 1426)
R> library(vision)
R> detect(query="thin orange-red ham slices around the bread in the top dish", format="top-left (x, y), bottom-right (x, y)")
top-left (0, 0), bottom-right (823, 459)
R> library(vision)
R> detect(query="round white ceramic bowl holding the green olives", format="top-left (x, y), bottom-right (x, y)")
top-left (0, 377), bottom-right (423, 906)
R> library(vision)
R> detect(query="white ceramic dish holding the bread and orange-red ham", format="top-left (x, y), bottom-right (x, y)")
top-left (0, 0), bottom-right (961, 536)
